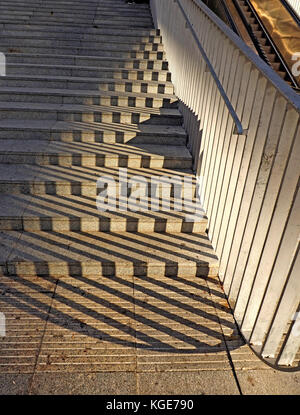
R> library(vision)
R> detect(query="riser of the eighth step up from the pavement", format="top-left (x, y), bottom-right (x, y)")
top-left (0, 77), bottom-right (174, 94)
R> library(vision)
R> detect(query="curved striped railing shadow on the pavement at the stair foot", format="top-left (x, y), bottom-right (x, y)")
top-left (0, 226), bottom-right (244, 354)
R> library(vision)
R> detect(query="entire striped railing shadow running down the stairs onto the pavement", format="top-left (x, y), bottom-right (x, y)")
top-left (0, 12), bottom-right (243, 364)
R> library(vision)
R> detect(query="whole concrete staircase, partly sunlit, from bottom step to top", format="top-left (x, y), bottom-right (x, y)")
top-left (0, 1), bottom-right (217, 277)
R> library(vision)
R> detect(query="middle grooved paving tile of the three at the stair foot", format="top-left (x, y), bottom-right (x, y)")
top-left (37, 277), bottom-right (136, 372)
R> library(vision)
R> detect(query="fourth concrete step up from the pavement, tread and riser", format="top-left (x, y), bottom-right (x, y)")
top-left (0, 139), bottom-right (192, 169)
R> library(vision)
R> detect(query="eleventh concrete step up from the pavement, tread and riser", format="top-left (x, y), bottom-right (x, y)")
top-left (0, 45), bottom-right (165, 60)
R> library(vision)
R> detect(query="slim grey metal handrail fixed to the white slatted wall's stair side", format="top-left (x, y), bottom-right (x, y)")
top-left (174, 0), bottom-right (247, 135)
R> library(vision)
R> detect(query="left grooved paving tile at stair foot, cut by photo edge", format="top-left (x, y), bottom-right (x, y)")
top-left (0, 276), bottom-right (56, 374)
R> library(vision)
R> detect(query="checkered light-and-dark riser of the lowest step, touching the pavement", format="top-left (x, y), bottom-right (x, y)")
top-left (2, 261), bottom-right (218, 278)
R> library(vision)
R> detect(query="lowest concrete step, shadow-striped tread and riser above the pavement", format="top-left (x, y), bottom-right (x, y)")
top-left (0, 231), bottom-right (218, 278)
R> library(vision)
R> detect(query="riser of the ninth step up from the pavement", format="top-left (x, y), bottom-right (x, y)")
top-left (6, 64), bottom-right (171, 82)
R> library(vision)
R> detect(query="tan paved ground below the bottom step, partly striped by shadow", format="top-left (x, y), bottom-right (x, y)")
top-left (0, 276), bottom-right (300, 395)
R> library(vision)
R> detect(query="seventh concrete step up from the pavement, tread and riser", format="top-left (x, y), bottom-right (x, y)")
top-left (0, 87), bottom-right (177, 108)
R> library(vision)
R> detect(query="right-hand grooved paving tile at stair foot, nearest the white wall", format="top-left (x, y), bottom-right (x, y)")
top-left (134, 276), bottom-right (234, 373)
